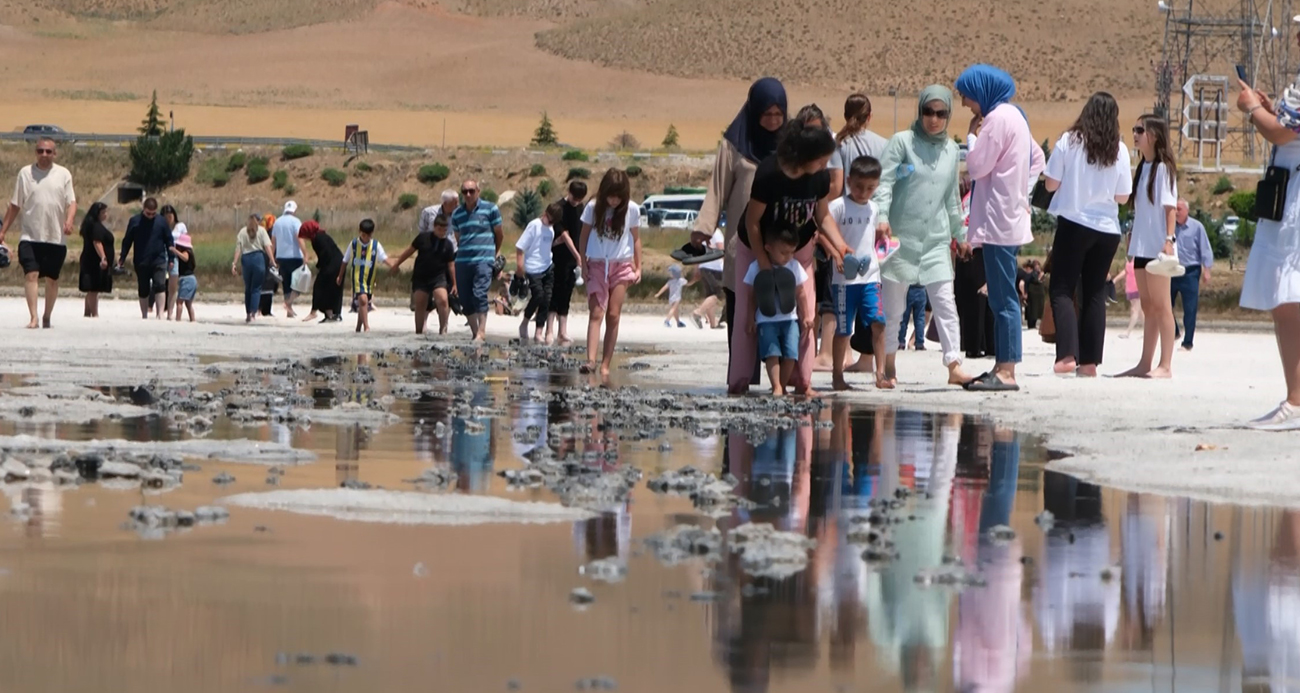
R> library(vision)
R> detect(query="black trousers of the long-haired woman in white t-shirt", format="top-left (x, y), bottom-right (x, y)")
top-left (1048, 217), bottom-right (1119, 365)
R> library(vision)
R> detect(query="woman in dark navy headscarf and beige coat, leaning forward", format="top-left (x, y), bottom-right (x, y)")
top-left (696, 77), bottom-right (787, 384)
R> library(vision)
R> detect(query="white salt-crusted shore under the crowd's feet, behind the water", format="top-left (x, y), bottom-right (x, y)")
top-left (0, 295), bottom-right (1284, 507)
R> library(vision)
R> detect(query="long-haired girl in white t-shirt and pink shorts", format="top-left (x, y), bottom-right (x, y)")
top-left (577, 169), bottom-right (641, 376)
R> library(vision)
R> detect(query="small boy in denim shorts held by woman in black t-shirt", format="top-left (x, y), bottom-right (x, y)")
top-left (742, 221), bottom-right (813, 397)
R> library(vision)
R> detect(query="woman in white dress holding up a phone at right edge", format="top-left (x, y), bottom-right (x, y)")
top-left (1236, 81), bottom-right (1300, 430)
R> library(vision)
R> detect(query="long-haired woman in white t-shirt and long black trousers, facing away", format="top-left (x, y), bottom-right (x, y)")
top-left (1044, 91), bottom-right (1134, 377)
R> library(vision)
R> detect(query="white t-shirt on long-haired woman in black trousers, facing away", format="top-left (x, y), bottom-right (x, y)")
top-left (1044, 133), bottom-right (1134, 235)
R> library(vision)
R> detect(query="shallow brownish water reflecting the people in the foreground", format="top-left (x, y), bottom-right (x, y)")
top-left (0, 353), bottom-right (1300, 692)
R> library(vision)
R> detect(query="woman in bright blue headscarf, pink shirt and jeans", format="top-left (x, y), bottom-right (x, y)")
top-left (957, 65), bottom-right (1045, 391)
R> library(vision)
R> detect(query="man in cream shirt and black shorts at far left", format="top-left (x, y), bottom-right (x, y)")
top-left (0, 138), bottom-right (77, 330)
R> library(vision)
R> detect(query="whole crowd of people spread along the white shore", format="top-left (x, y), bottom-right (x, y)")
top-left (0, 56), bottom-right (1300, 430)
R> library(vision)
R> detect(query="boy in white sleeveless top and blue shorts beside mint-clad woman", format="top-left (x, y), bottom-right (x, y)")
top-left (829, 156), bottom-right (893, 390)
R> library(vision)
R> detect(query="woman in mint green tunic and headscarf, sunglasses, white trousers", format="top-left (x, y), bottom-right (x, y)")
top-left (874, 85), bottom-right (970, 385)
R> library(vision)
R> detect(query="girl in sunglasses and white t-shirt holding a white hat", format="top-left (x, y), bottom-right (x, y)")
top-left (1119, 114), bottom-right (1178, 378)
